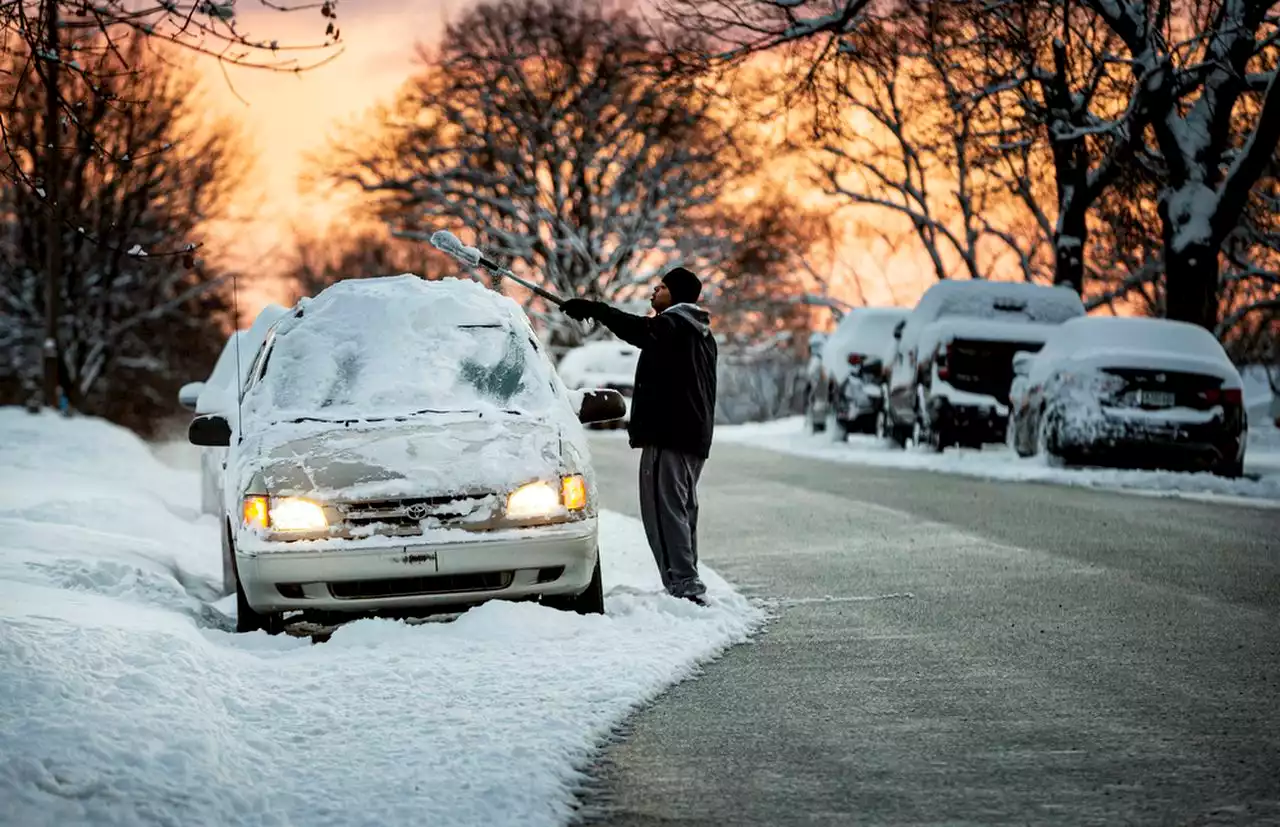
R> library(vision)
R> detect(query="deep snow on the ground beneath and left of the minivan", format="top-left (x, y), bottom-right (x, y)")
top-left (0, 408), bottom-right (762, 827)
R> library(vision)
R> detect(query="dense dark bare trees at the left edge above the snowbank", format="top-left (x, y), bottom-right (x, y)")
top-left (0, 35), bottom-right (238, 435)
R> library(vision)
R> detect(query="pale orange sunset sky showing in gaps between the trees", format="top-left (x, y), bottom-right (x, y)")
top-left (197, 0), bottom-right (932, 321)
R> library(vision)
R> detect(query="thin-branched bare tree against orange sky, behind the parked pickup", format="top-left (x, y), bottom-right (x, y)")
top-left (814, 4), bottom-right (1044, 285)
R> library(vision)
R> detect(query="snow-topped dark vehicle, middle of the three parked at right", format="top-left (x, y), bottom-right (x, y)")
top-left (877, 280), bottom-right (1084, 451)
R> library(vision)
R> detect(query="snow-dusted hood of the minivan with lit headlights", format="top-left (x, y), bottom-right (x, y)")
top-left (251, 420), bottom-right (564, 501)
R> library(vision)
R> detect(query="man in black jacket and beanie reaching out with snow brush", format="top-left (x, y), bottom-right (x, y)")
top-left (561, 268), bottom-right (717, 606)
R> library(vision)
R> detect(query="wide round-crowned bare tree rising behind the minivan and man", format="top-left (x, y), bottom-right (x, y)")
top-left (332, 0), bottom-right (740, 348)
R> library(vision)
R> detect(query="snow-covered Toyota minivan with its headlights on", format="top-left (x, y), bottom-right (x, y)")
top-left (189, 275), bottom-right (623, 632)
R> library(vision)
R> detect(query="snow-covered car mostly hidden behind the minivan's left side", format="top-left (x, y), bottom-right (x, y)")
top-left (178, 303), bottom-right (288, 515)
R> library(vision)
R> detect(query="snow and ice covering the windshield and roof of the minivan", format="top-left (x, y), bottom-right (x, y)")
top-left (247, 277), bottom-right (556, 421)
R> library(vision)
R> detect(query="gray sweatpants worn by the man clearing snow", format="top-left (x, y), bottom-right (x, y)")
top-left (640, 447), bottom-right (707, 598)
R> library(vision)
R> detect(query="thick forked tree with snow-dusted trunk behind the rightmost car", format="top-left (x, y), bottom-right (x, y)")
top-left (1087, 0), bottom-right (1280, 329)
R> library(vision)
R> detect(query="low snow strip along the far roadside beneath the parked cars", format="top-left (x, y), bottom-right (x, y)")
top-left (712, 416), bottom-right (1280, 503)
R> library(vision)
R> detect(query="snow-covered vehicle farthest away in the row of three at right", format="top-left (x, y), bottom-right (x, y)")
top-left (806, 307), bottom-right (910, 440)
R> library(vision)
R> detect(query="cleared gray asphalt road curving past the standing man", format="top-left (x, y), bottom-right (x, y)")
top-left (581, 438), bottom-right (1280, 827)
